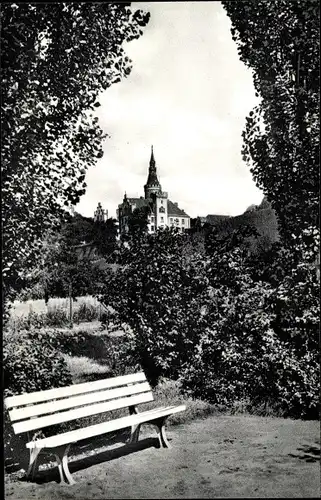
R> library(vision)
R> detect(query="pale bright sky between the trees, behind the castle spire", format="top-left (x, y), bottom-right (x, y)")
top-left (76, 1), bottom-right (263, 217)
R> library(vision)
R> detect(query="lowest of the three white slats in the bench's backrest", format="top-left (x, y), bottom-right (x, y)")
top-left (12, 392), bottom-right (154, 434)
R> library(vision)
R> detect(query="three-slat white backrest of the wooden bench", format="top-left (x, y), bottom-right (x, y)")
top-left (4, 372), bottom-right (154, 434)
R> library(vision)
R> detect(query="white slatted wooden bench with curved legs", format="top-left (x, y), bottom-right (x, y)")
top-left (4, 372), bottom-right (186, 484)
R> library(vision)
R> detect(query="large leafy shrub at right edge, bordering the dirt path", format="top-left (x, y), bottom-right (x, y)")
top-left (182, 264), bottom-right (320, 419)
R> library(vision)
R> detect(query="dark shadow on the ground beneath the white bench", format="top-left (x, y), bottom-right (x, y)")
top-left (20, 438), bottom-right (159, 484)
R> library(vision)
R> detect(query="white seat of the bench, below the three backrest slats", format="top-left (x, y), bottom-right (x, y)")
top-left (27, 405), bottom-right (186, 448)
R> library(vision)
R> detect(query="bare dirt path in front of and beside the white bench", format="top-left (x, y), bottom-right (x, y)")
top-left (5, 416), bottom-right (320, 500)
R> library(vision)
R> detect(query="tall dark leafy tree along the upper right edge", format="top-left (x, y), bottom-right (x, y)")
top-left (222, 0), bottom-right (320, 260)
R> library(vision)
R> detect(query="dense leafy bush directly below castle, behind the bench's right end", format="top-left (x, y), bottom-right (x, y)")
top-left (102, 230), bottom-right (207, 385)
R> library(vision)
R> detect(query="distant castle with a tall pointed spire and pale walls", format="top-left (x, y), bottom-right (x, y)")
top-left (117, 146), bottom-right (190, 234)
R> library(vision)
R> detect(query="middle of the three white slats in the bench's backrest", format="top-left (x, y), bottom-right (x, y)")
top-left (9, 382), bottom-right (151, 422)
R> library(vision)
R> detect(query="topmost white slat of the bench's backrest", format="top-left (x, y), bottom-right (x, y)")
top-left (4, 372), bottom-right (146, 409)
